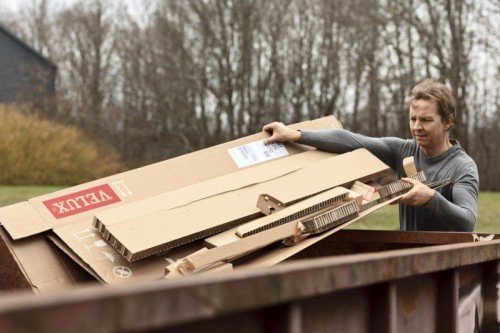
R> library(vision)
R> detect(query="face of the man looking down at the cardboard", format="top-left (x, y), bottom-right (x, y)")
top-left (410, 99), bottom-right (448, 156)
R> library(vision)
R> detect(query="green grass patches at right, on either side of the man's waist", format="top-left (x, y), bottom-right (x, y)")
top-left (349, 192), bottom-right (500, 233)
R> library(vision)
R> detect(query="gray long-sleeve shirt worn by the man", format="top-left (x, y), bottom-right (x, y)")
top-left (299, 129), bottom-right (479, 232)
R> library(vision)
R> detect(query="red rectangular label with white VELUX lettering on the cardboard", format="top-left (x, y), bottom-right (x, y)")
top-left (43, 184), bottom-right (121, 219)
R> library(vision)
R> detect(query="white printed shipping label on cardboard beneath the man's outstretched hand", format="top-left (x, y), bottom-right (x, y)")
top-left (228, 140), bottom-right (288, 168)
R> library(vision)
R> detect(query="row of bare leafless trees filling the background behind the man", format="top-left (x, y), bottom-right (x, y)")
top-left (0, 0), bottom-right (500, 190)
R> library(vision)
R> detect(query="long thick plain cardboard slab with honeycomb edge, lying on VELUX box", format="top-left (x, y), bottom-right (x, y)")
top-left (99, 149), bottom-right (389, 261)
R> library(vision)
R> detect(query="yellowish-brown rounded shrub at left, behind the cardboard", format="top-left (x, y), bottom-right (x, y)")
top-left (0, 105), bottom-right (123, 186)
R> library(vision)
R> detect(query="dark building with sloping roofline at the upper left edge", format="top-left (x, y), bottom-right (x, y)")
top-left (0, 25), bottom-right (57, 104)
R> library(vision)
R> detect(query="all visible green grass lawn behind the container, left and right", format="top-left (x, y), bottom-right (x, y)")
top-left (0, 186), bottom-right (500, 233)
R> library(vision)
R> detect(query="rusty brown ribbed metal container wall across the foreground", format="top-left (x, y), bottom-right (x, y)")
top-left (0, 232), bottom-right (500, 333)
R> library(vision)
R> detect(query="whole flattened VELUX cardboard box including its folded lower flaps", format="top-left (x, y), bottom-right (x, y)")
top-left (0, 117), bottom-right (341, 292)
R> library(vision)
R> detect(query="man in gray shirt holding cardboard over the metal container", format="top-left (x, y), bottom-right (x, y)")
top-left (263, 80), bottom-right (479, 232)
